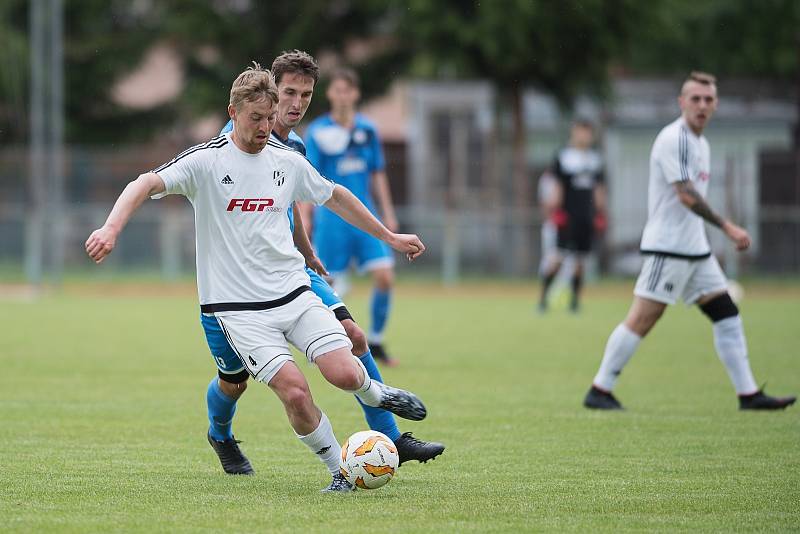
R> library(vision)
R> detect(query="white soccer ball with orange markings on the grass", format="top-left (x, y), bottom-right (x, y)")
top-left (339, 430), bottom-right (400, 489)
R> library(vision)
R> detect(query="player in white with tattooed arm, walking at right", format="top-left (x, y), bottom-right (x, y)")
top-left (584, 72), bottom-right (796, 410)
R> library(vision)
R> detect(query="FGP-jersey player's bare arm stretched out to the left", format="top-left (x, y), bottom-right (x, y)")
top-left (86, 172), bottom-right (166, 263)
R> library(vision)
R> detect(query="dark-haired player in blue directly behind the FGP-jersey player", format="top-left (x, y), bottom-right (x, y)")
top-left (206, 50), bottom-right (445, 474)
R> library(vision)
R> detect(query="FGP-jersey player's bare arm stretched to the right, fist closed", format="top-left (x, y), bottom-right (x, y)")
top-left (325, 185), bottom-right (425, 261)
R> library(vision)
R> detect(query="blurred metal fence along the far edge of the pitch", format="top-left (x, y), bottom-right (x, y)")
top-left (0, 141), bottom-right (800, 283)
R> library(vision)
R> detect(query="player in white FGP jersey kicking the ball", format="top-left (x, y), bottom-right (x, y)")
top-left (86, 64), bottom-right (426, 491)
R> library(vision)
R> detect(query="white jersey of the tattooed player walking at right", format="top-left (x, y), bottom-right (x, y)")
top-left (641, 117), bottom-right (711, 258)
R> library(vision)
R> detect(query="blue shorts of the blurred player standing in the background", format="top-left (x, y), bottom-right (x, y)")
top-left (314, 224), bottom-right (394, 274)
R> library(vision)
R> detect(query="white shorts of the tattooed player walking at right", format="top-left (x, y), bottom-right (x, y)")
top-left (633, 254), bottom-right (728, 304)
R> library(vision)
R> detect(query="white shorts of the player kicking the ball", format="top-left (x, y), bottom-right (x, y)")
top-left (214, 291), bottom-right (353, 384)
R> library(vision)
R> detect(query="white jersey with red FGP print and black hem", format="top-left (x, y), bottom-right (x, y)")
top-left (153, 133), bottom-right (335, 313)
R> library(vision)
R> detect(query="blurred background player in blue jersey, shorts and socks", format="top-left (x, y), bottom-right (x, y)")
top-left (305, 69), bottom-right (398, 365)
